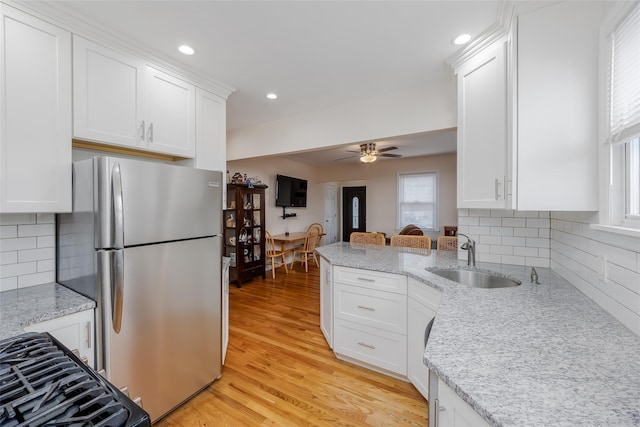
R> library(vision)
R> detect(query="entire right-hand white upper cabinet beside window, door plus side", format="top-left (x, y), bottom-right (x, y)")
top-left (456, 2), bottom-right (602, 211)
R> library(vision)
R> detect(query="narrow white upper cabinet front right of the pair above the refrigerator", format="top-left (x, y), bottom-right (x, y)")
top-left (195, 88), bottom-right (227, 172)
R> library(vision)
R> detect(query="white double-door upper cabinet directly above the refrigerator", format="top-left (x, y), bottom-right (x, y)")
top-left (73, 36), bottom-right (196, 157)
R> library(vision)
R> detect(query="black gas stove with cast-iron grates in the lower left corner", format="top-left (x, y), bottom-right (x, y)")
top-left (0, 333), bottom-right (151, 427)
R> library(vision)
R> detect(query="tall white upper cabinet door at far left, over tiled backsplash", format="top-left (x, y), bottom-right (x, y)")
top-left (0, 5), bottom-right (71, 212)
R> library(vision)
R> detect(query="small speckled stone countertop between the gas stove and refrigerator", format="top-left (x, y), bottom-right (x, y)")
top-left (0, 283), bottom-right (95, 339)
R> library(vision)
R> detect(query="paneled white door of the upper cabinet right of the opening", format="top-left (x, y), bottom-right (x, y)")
top-left (457, 42), bottom-right (509, 208)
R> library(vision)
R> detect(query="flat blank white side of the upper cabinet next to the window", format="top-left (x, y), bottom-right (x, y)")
top-left (517, 2), bottom-right (602, 211)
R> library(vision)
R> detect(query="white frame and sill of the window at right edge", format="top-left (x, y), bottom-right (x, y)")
top-left (592, 2), bottom-right (640, 237)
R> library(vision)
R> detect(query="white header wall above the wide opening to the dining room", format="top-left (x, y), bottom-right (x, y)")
top-left (227, 81), bottom-right (457, 161)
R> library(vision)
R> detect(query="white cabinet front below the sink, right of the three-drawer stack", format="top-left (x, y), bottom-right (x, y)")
top-left (407, 278), bottom-right (442, 400)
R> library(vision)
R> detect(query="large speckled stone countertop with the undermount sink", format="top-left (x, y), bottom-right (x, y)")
top-left (317, 243), bottom-right (640, 427)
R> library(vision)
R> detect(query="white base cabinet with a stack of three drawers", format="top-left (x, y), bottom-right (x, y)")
top-left (332, 267), bottom-right (407, 377)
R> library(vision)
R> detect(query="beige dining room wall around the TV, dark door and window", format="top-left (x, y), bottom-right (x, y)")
top-left (227, 153), bottom-right (458, 240)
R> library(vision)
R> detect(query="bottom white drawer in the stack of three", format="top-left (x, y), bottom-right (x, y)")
top-left (333, 319), bottom-right (407, 376)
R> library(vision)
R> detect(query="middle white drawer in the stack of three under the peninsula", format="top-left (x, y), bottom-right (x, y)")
top-left (334, 283), bottom-right (407, 334)
